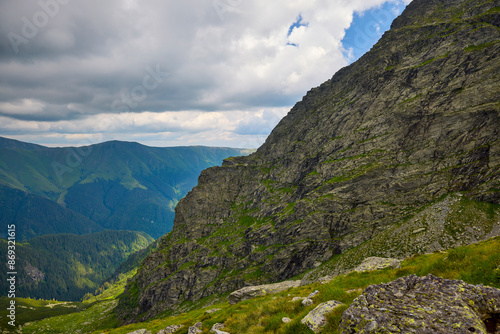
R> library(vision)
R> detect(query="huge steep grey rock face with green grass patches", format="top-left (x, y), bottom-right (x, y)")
top-left (117, 0), bottom-right (500, 322)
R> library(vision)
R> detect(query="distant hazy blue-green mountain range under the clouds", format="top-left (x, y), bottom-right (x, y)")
top-left (0, 139), bottom-right (249, 239)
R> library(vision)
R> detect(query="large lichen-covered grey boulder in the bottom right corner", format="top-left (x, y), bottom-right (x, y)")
top-left (340, 275), bottom-right (500, 334)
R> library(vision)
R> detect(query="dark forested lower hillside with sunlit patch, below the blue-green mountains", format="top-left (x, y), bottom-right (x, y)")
top-left (0, 231), bottom-right (153, 301)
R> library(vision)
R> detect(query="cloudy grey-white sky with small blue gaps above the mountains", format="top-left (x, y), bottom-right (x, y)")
top-left (0, 0), bottom-right (411, 148)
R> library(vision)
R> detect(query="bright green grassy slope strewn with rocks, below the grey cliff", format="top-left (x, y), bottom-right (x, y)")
top-left (17, 237), bottom-right (500, 334)
